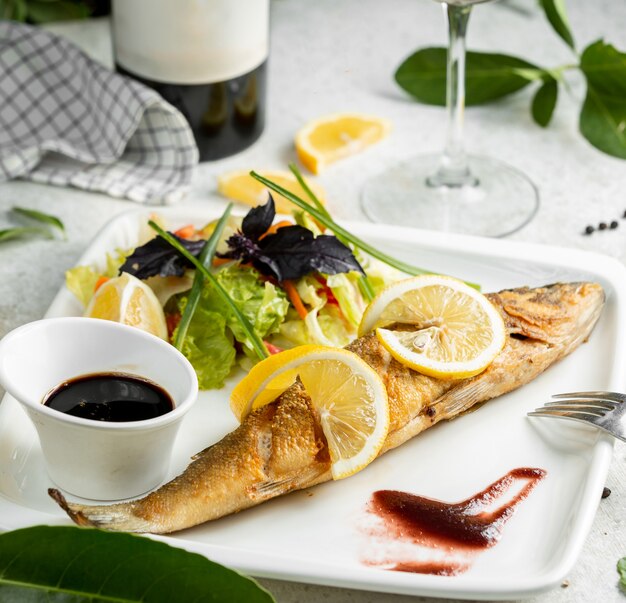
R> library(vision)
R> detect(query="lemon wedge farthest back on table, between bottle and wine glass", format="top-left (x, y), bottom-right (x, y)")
top-left (296, 113), bottom-right (391, 174)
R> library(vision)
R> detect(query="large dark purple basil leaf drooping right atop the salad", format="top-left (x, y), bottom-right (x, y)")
top-left (254, 226), bottom-right (363, 281)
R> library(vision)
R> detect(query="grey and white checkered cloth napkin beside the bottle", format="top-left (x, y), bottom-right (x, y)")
top-left (0, 21), bottom-right (198, 204)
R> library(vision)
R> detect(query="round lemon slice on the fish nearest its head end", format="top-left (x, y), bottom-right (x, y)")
top-left (359, 275), bottom-right (506, 379)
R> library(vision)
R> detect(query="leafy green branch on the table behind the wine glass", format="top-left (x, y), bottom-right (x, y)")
top-left (395, 0), bottom-right (626, 159)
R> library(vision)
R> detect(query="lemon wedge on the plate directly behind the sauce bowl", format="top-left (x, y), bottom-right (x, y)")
top-left (85, 272), bottom-right (168, 341)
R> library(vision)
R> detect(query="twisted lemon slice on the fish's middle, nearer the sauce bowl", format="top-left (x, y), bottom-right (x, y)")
top-left (230, 345), bottom-right (389, 479)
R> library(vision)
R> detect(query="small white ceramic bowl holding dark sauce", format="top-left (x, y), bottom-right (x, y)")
top-left (0, 317), bottom-right (198, 500)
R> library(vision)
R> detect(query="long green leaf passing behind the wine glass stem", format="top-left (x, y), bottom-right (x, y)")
top-left (395, 48), bottom-right (545, 105)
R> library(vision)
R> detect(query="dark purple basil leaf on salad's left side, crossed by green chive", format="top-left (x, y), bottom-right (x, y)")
top-left (119, 233), bottom-right (206, 280)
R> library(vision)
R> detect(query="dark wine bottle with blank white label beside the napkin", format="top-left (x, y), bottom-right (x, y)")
top-left (112, 0), bottom-right (269, 161)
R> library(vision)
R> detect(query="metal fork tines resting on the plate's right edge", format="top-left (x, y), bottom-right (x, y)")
top-left (528, 392), bottom-right (626, 442)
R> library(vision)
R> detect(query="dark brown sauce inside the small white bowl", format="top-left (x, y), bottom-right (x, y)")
top-left (43, 373), bottom-right (174, 423)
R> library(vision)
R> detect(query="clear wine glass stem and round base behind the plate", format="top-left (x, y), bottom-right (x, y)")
top-left (362, 0), bottom-right (539, 237)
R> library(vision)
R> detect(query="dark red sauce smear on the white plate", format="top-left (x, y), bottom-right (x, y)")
top-left (366, 468), bottom-right (546, 575)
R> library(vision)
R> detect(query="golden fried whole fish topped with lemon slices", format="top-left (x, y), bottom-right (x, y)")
top-left (49, 283), bottom-right (604, 534)
